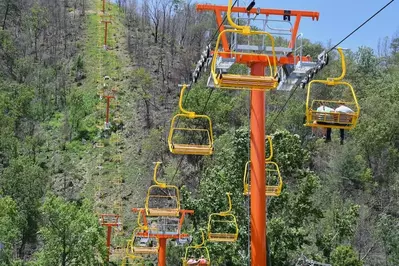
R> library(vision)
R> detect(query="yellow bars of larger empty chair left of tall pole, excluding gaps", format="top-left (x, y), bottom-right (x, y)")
top-left (168, 84), bottom-right (213, 155)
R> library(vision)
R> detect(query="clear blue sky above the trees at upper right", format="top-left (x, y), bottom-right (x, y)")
top-left (197, 0), bottom-right (399, 51)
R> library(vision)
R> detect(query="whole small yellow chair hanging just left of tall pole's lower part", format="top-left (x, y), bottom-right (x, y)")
top-left (208, 193), bottom-right (238, 242)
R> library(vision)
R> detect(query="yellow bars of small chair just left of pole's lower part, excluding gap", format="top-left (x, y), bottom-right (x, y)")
top-left (208, 193), bottom-right (238, 242)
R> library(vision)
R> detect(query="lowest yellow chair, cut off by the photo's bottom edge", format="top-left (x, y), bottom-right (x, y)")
top-left (182, 232), bottom-right (211, 266)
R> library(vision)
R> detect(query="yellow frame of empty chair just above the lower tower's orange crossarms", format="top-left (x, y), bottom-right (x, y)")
top-left (145, 162), bottom-right (180, 217)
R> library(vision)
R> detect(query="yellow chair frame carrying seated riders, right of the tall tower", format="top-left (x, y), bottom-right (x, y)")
top-left (305, 48), bottom-right (360, 129)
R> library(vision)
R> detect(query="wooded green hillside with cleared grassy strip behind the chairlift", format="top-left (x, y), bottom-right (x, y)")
top-left (0, 0), bottom-right (399, 266)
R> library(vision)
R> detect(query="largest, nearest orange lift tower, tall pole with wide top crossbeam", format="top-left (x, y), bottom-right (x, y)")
top-left (197, 1), bottom-right (319, 266)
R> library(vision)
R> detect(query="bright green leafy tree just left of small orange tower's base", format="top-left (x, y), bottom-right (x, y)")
top-left (35, 194), bottom-right (106, 266)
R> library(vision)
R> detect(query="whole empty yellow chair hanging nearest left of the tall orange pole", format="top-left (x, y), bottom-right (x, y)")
top-left (168, 84), bottom-right (213, 155)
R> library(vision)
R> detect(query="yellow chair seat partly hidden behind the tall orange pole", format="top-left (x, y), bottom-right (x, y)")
top-left (244, 161), bottom-right (283, 196)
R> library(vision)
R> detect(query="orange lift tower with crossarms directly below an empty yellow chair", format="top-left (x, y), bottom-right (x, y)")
top-left (132, 208), bottom-right (194, 266)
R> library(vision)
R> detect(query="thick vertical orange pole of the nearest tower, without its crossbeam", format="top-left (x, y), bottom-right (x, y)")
top-left (251, 63), bottom-right (267, 266)
